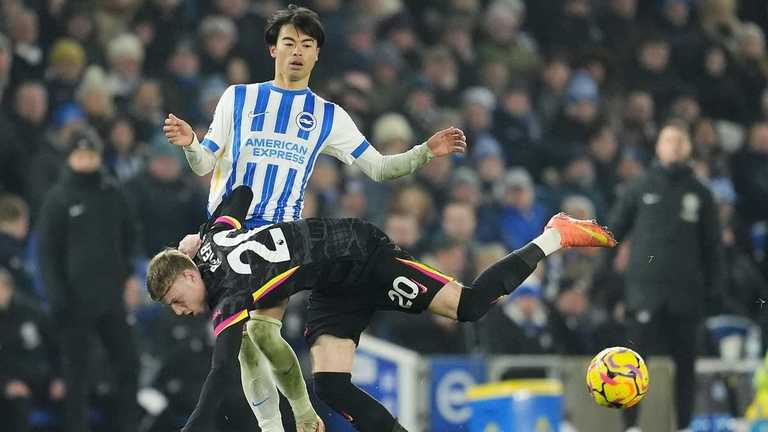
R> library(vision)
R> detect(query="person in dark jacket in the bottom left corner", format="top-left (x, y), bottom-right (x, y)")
top-left (0, 268), bottom-right (66, 432)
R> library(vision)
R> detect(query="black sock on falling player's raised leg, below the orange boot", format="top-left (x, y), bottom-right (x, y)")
top-left (456, 243), bottom-right (545, 321)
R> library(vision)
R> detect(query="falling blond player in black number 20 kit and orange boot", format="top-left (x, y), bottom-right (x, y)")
top-left (147, 187), bottom-right (616, 432)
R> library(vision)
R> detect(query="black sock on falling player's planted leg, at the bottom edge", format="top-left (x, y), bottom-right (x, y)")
top-left (314, 372), bottom-right (396, 432)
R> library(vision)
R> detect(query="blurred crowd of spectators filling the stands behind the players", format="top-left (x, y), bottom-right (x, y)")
top-left (0, 0), bottom-right (768, 427)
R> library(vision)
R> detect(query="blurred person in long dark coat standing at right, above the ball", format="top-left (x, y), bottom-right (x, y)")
top-left (609, 123), bottom-right (724, 429)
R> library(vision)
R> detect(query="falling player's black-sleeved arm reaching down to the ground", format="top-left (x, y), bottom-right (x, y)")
top-left (181, 321), bottom-right (245, 432)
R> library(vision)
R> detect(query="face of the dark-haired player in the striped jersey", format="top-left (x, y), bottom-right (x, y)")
top-left (269, 24), bottom-right (320, 82)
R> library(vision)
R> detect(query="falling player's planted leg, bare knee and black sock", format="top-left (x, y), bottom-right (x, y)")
top-left (310, 334), bottom-right (406, 432)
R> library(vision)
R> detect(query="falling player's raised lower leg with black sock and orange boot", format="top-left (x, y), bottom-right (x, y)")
top-left (429, 213), bottom-right (616, 321)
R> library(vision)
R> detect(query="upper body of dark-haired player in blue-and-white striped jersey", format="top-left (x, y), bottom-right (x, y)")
top-left (163, 5), bottom-right (466, 228)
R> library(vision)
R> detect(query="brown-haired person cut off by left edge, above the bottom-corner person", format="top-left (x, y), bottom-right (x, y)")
top-left (0, 194), bottom-right (34, 299)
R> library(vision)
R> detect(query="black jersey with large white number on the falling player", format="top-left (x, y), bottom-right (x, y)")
top-left (195, 196), bottom-right (386, 335)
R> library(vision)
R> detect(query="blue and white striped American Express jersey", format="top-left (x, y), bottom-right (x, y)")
top-left (200, 81), bottom-right (370, 227)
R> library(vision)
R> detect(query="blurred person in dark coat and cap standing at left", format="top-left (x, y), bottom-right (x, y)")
top-left (38, 128), bottom-right (138, 432)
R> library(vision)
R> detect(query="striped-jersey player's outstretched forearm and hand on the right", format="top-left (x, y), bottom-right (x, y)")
top-left (355, 127), bottom-right (467, 181)
